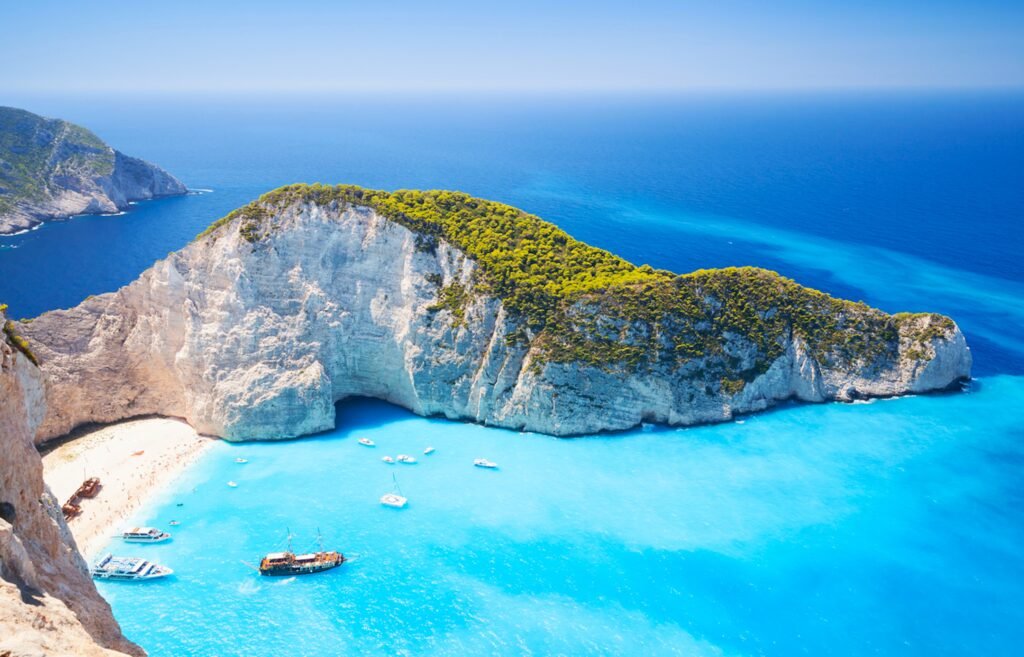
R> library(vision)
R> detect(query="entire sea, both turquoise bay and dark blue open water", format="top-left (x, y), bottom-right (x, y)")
top-left (0, 93), bottom-right (1024, 657)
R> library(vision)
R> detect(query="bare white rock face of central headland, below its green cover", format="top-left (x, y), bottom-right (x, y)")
top-left (22, 196), bottom-right (971, 440)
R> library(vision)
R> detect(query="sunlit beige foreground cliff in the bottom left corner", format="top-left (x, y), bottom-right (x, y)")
top-left (0, 310), bottom-right (143, 657)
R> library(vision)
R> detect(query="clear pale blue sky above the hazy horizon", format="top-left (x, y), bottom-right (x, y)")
top-left (0, 0), bottom-right (1024, 93)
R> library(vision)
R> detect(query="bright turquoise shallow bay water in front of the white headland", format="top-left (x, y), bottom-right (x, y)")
top-left (100, 377), bottom-right (1024, 656)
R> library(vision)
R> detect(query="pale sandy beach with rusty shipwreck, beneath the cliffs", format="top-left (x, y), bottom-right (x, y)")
top-left (43, 418), bottom-right (217, 560)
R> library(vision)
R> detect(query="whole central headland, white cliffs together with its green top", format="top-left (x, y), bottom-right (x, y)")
top-left (19, 185), bottom-right (971, 440)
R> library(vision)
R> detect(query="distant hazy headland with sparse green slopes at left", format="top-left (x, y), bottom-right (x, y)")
top-left (0, 107), bottom-right (187, 234)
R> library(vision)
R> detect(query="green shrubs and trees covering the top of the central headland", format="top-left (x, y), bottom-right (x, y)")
top-left (200, 184), bottom-right (952, 384)
